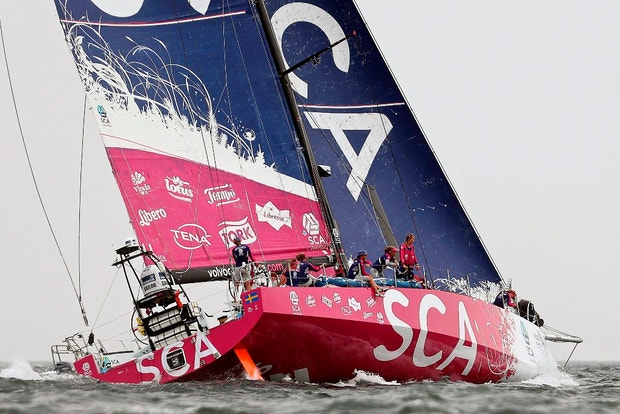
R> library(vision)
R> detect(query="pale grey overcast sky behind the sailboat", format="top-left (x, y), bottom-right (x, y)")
top-left (0, 0), bottom-right (620, 362)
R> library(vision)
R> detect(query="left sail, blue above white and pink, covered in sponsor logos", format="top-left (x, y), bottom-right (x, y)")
top-left (56, 0), bottom-right (330, 282)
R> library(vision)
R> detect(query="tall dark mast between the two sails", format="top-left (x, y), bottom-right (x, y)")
top-left (254, 0), bottom-right (347, 271)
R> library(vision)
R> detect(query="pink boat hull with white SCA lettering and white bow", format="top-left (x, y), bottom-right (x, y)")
top-left (75, 287), bottom-right (546, 383)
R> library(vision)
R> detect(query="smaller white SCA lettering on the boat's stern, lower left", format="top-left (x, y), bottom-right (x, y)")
top-left (136, 332), bottom-right (220, 382)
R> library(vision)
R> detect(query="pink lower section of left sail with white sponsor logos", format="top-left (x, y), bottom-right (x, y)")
top-left (108, 148), bottom-right (330, 277)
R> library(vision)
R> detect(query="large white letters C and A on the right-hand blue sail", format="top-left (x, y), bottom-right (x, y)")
top-left (271, 2), bottom-right (392, 201)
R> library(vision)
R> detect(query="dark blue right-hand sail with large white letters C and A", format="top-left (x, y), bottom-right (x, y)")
top-left (266, 0), bottom-right (501, 287)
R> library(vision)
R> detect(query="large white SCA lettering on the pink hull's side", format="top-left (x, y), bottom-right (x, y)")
top-left (374, 290), bottom-right (478, 375)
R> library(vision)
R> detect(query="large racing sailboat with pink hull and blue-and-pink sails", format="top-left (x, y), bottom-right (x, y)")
top-left (52, 0), bottom-right (581, 383)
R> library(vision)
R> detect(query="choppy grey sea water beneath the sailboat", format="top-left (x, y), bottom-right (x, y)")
top-left (0, 361), bottom-right (620, 414)
